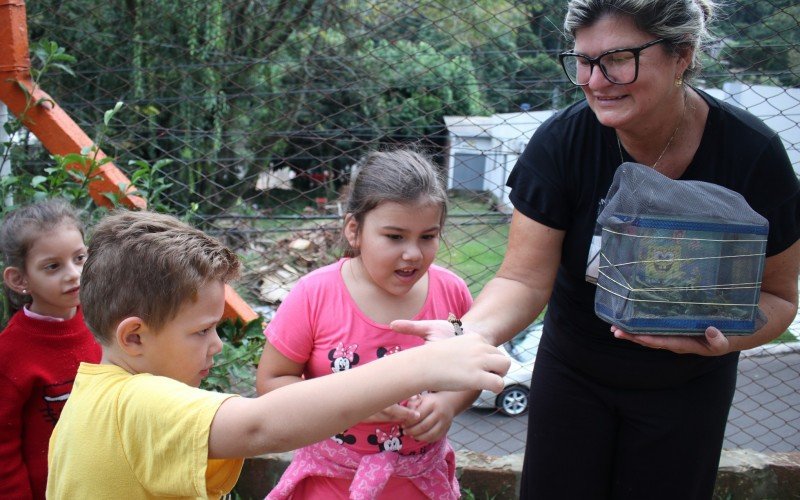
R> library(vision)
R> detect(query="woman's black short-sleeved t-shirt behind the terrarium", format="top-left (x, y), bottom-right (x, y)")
top-left (507, 91), bottom-right (800, 388)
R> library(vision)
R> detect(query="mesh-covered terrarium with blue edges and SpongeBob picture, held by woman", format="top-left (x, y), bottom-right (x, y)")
top-left (595, 163), bottom-right (769, 335)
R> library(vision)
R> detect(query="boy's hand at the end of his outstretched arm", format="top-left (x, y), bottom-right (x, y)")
top-left (422, 336), bottom-right (511, 393)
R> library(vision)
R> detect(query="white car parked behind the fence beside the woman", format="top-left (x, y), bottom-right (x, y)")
top-left (472, 321), bottom-right (542, 417)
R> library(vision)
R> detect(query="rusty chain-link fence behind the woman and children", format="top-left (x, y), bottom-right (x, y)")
top-left (11, 0), bottom-right (800, 455)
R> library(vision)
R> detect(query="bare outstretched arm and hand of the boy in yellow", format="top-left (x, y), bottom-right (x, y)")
top-left (208, 335), bottom-right (510, 458)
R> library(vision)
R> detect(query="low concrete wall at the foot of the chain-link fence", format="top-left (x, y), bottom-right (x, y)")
top-left (235, 450), bottom-right (800, 500)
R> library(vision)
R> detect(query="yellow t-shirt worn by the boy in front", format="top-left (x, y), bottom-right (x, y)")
top-left (47, 363), bottom-right (244, 500)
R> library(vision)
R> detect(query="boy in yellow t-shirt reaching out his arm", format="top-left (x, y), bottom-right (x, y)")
top-left (47, 211), bottom-right (509, 499)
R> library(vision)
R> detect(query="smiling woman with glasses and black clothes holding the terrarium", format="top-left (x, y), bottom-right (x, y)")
top-left (395, 0), bottom-right (800, 499)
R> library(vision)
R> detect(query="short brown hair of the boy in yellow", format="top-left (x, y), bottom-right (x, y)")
top-left (80, 210), bottom-right (239, 345)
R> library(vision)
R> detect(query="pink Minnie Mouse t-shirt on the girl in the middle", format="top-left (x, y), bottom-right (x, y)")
top-left (265, 259), bottom-right (472, 455)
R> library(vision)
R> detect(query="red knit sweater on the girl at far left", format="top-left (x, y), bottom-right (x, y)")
top-left (0, 308), bottom-right (102, 499)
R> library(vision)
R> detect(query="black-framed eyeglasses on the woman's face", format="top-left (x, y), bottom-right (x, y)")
top-left (558, 38), bottom-right (667, 87)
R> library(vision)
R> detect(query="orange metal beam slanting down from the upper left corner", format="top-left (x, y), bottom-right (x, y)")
top-left (0, 0), bottom-right (258, 322)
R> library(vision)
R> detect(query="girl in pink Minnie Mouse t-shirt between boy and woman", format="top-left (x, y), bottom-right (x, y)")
top-left (257, 150), bottom-right (476, 500)
